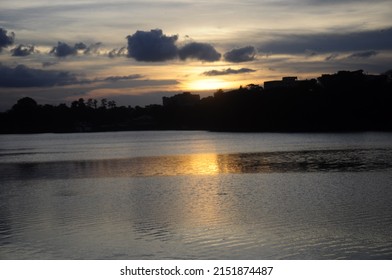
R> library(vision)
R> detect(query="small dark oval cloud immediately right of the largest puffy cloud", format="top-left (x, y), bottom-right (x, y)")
top-left (178, 42), bottom-right (221, 62)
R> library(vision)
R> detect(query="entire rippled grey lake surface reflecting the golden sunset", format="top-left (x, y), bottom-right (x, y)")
top-left (0, 131), bottom-right (392, 259)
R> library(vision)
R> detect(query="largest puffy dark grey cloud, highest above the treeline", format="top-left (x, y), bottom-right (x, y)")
top-left (127, 29), bottom-right (178, 62)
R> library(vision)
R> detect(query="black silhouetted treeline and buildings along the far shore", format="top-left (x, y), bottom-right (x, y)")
top-left (0, 70), bottom-right (392, 133)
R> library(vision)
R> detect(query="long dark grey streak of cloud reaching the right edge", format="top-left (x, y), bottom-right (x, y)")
top-left (260, 28), bottom-right (392, 54)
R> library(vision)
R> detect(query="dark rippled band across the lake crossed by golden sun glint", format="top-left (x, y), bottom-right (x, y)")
top-left (0, 149), bottom-right (392, 180)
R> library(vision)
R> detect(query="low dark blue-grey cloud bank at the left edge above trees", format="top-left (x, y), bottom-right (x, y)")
top-left (0, 65), bottom-right (78, 87)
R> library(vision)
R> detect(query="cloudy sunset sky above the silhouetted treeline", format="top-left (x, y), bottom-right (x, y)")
top-left (0, 0), bottom-right (392, 111)
